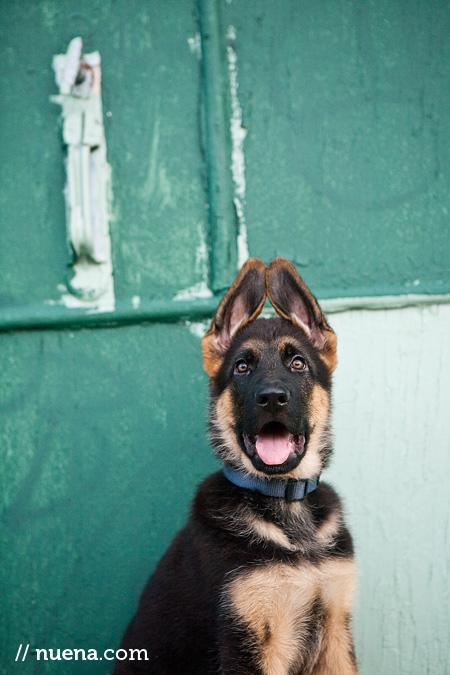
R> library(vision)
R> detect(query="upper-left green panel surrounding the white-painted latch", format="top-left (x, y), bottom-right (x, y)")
top-left (0, 0), bottom-right (206, 305)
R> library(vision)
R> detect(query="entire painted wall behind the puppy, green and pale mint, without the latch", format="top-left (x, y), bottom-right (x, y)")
top-left (0, 0), bottom-right (450, 675)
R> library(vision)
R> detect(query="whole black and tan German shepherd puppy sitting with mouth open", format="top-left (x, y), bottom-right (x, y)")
top-left (114, 258), bottom-right (357, 675)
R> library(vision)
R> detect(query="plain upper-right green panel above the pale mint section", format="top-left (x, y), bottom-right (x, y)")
top-left (224, 0), bottom-right (450, 297)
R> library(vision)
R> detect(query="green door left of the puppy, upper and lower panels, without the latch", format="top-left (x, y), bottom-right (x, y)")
top-left (0, 0), bottom-right (222, 673)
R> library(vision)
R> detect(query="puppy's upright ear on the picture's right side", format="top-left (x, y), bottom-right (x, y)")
top-left (266, 258), bottom-right (337, 369)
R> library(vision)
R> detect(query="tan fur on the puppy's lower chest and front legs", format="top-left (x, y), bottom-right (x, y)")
top-left (228, 560), bottom-right (356, 675)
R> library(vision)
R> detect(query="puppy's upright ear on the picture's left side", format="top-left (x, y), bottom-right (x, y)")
top-left (202, 258), bottom-right (266, 377)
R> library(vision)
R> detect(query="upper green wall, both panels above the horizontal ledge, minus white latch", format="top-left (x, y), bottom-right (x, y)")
top-left (0, 0), bottom-right (450, 325)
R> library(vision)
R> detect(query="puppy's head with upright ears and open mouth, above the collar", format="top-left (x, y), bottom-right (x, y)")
top-left (202, 258), bottom-right (336, 478)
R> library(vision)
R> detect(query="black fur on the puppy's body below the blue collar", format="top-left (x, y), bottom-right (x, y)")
top-left (114, 472), bottom-right (353, 675)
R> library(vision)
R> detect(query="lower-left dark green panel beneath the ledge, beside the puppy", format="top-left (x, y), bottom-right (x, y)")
top-left (0, 325), bottom-right (216, 673)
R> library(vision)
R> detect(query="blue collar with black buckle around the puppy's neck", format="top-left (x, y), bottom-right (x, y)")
top-left (223, 464), bottom-right (319, 502)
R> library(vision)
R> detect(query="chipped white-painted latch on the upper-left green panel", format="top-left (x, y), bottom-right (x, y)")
top-left (52, 37), bottom-right (114, 309)
